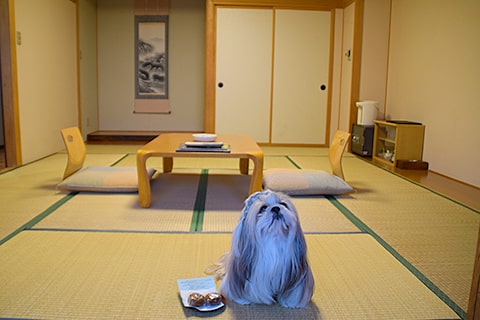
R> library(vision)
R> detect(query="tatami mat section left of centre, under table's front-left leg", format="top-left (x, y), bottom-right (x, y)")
top-left (34, 170), bottom-right (200, 232)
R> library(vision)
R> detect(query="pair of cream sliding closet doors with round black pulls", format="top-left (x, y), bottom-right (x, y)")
top-left (215, 7), bottom-right (331, 145)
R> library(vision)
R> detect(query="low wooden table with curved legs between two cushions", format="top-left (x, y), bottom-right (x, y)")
top-left (137, 133), bottom-right (263, 208)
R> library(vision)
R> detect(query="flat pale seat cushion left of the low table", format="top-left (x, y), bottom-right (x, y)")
top-left (57, 167), bottom-right (155, 192)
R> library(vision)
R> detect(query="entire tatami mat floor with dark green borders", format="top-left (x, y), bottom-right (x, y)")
top-left (0, 145), bottom-right (480, 319)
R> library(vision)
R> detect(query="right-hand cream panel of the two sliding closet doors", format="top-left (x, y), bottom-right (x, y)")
top-left (272, 10), bottom-right (330, 144)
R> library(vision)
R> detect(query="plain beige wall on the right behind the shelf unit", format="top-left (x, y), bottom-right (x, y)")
top-left (386, 0), bottom-right (480, 186)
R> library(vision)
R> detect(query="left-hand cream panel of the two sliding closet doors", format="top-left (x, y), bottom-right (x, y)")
top-left (215, 8), bottom-right (273, 142)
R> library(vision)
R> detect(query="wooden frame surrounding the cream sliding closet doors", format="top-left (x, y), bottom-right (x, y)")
top-left (204, 0), bottom-right (364, 145)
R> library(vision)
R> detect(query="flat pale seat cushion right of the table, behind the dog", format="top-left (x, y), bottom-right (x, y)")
top-left (263, 168), bottom-right (353, 195)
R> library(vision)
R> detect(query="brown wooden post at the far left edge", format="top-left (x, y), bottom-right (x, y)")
top-left (0, 0), bottom-right (22, 168)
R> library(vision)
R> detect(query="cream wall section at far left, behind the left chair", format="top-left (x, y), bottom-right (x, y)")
top-left (15, 0), bottom-right (77, 163)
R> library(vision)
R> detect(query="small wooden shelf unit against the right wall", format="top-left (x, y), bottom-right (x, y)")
top-left (372, 120), bottom-right (425, 167)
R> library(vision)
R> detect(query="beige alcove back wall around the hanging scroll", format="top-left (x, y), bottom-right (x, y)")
top-left (97, 0), bottom-right (205, 131)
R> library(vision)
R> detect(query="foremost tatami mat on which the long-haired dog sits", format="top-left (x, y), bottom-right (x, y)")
top-left (0, 231), bottom-right (456, 320)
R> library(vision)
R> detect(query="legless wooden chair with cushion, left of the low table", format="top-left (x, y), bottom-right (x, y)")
top-left (57, 127), bottom-right (155, 192)
